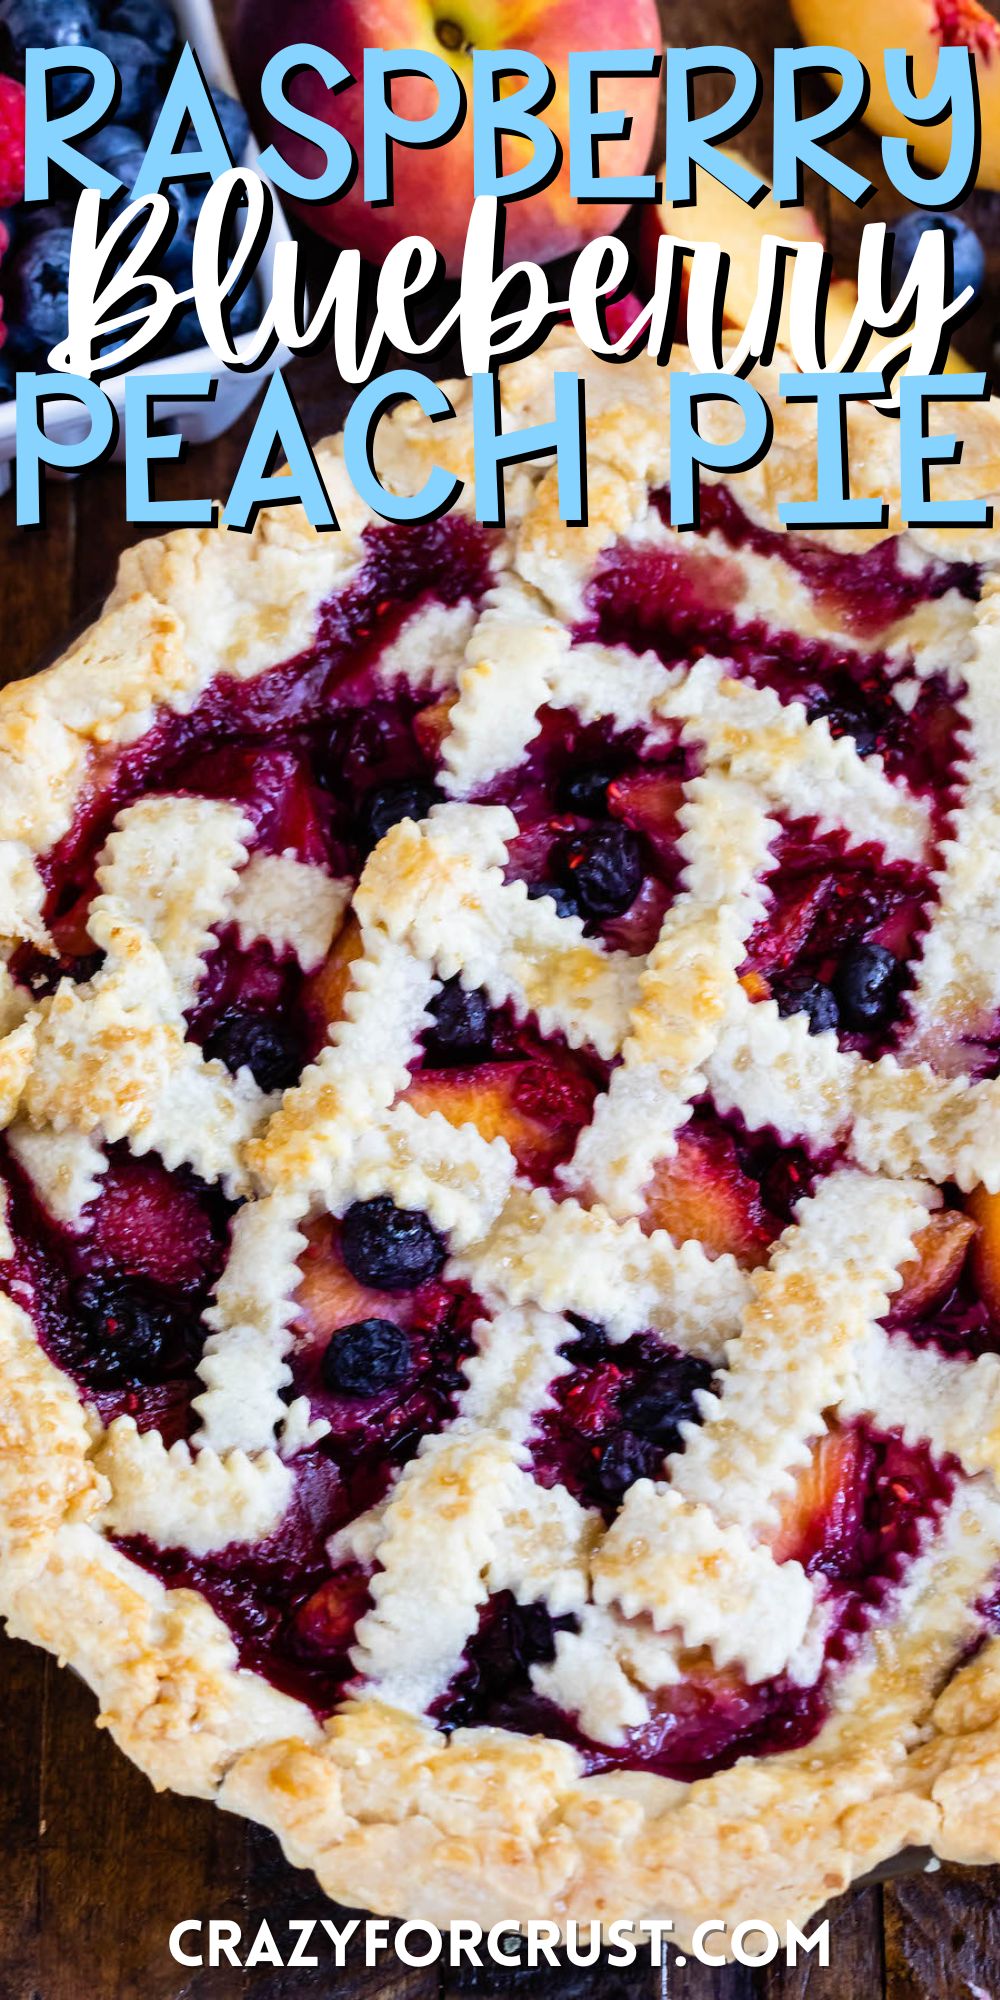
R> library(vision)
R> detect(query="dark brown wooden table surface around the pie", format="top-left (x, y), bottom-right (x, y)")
top-left (0, 0), bottom-right (1000, 2000)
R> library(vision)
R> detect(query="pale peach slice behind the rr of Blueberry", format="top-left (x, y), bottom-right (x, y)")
top-left (640, 148), bottom-right (824, 338)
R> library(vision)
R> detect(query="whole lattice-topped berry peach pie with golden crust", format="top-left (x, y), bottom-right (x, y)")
top-left (0, 332), bottom-right (1000, 1936)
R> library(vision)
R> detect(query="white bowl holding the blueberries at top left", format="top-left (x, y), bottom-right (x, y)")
top-left (0, 0), bottom-right (292, 494)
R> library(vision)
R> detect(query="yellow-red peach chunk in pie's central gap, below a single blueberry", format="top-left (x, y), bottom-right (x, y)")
top-left (406, 1058), bottom-right (596, 1178)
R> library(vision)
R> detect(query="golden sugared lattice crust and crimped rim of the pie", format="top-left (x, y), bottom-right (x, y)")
top-left (0, 334), bottom-right (1000, 1938)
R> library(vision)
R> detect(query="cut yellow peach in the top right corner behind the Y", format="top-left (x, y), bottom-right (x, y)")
top-left (792, 0), bottom-right (1000, 188)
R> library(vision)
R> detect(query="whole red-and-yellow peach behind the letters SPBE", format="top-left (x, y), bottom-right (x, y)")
top-left (234, 0), bottom-right (662, 276)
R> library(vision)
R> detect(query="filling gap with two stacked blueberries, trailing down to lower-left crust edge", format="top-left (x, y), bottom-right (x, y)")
top-left (120, 1196), bottom-right (480, 1714)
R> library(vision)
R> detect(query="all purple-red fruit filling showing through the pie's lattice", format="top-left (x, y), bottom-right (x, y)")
top-left (0, 486), bottom-right (1000, 1780)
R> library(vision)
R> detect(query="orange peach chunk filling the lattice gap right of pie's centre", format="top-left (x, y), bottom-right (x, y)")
top-left (640, 1132), bottom-right (774, 1264)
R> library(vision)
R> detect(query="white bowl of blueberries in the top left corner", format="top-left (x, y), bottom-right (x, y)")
top-left (0, 0), bottom-right (290, 494)
